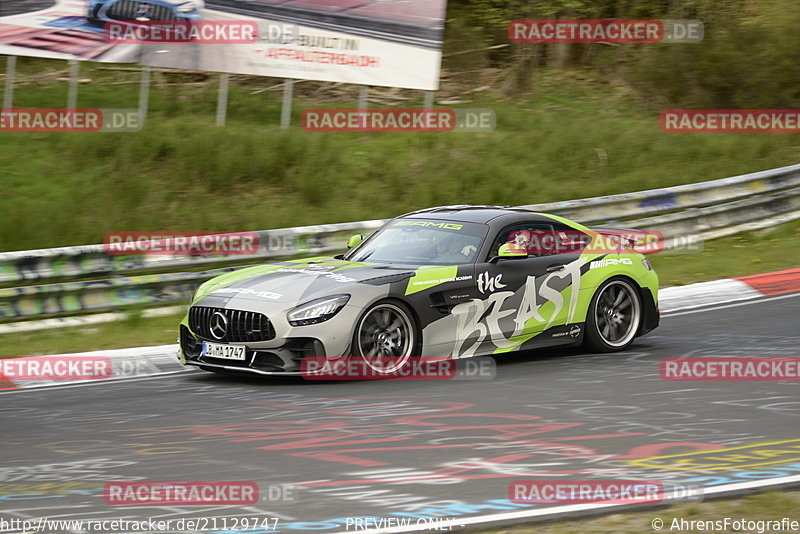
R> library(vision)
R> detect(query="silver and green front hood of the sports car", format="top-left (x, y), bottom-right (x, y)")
top-left (194, 259), bottom-right (417, 308)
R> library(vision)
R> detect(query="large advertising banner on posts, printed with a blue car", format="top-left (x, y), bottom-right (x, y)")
top-left (0, 0), bottom-right (446, 91)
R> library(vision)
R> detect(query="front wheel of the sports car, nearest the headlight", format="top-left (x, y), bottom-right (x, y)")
top-left (353, 302), bottom-right (418, 374)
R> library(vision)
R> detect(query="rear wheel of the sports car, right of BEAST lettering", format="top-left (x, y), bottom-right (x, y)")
top-left (584, 278), bottom-right (642, 352)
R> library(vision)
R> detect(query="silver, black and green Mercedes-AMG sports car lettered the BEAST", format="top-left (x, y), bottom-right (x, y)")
top-left (179, 206), bottom-right (659, 375)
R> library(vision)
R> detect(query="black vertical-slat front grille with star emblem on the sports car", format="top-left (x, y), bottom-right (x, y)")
top-left (189, 306), bottom-right (275, 343)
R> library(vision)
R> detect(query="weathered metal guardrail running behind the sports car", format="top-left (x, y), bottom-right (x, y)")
top-left (0, 165), bottom-right (800, 321)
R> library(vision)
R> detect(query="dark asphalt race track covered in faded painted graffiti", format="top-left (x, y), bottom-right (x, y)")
top-left (0, 293), bottom-right (800, 532)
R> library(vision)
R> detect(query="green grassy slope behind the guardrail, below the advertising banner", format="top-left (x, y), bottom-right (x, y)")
top-left (0, 58), bottom-right (800, 250)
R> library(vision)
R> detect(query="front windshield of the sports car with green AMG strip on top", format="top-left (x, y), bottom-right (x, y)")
top-left (345, 219), bottom-right (489, 265)
